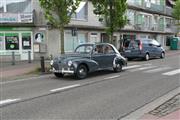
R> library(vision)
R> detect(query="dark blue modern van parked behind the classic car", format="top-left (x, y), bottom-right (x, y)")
top-left (123, 39), bottom-right (165, 60)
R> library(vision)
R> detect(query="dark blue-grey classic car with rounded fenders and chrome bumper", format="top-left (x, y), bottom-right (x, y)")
top-left (51, 43), bottom-right (127, 79)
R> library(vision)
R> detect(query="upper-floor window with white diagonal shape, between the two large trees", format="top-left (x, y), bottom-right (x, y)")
top-left (72, 2), bottom-right (88, 20)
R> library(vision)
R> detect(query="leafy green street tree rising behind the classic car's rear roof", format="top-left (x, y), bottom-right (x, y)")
top-left (92, 0), bottom-right (127, 43)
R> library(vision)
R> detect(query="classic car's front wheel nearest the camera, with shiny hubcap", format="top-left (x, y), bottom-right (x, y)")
top-left (75, 64), bottom-right (88, 79)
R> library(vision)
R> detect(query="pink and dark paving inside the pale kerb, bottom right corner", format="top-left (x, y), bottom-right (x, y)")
top-left (140, 93), bottom-right (180, 120)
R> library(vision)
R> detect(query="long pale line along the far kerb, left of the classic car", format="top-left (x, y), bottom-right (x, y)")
top-left (0, 75), bottom-right (51, 85)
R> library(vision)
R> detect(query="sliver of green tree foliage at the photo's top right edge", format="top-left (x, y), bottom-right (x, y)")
top-left (172, 0), bottom-right (180, 29)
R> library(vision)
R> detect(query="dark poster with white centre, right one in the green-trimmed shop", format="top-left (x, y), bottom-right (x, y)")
top-left (22, 36), bottom-right (31, 49)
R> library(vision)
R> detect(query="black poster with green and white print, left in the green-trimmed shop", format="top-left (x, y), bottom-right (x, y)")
top-left (5, 36), bottom-right (19, 50)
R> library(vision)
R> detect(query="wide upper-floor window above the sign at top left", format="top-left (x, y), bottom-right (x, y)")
top-left (0, 0), bottom-right (32, 13)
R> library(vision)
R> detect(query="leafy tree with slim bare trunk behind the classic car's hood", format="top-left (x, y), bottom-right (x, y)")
top-left (39, 0), bottom-right (81, 54)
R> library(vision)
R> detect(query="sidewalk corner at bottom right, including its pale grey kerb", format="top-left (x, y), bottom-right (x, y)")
top-left (121, 87), bottom-right (180, 120)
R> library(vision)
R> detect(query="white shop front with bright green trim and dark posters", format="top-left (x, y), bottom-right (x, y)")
top-left (0, 27), bottom-right (33, 61)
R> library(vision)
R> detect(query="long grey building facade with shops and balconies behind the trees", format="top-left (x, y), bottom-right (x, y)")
top-left (0, 0), bottom-right (177, 60)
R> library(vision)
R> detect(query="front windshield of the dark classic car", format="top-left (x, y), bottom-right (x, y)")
top-left (75, 45), bottom-right (93, 54)
